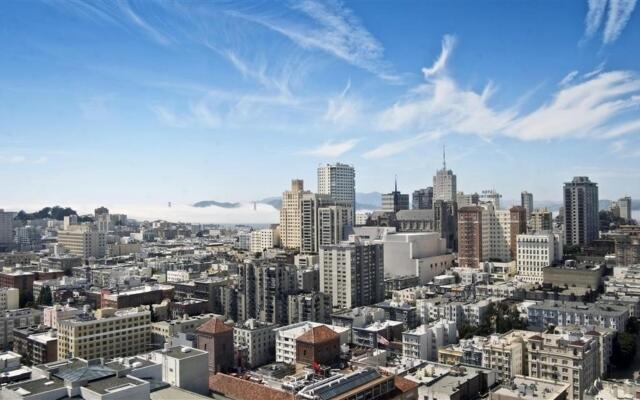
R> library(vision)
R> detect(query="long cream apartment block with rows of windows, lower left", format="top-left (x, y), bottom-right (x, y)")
top-left (58, 307), bottom-right (151, 359)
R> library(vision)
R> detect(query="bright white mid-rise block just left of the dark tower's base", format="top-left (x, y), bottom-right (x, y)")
top-left (516, 233), bottom-right (562, 283)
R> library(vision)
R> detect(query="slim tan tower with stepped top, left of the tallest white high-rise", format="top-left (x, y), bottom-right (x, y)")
top-left (280, 179), bottom-right (310, 249)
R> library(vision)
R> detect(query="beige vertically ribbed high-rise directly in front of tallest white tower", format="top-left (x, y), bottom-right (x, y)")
top-left (300, 193), bottom-right (353, 253)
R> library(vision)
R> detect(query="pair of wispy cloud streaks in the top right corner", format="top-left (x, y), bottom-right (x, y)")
top-left (585, 0), bottom-right (636, 44)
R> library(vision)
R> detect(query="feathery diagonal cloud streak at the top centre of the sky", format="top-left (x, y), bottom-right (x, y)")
top-left (228, 0), bottom-right (397, 80)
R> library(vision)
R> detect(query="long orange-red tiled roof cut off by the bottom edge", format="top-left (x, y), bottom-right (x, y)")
top-left (209, 374), bottom-right (295, 400)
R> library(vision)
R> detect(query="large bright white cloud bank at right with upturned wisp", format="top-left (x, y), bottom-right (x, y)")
top-left (377, 34), bottom-right (640, 140)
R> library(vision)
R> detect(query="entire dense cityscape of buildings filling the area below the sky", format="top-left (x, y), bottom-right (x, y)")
top-left (0, 155), bottom-right (640, 400)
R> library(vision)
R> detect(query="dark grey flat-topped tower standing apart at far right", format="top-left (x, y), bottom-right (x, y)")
top-left (564, 176), bottom-right (599, 245)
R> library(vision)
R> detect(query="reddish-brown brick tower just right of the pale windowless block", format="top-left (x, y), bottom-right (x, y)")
top-left (458, 206), bottom-right (482, 268)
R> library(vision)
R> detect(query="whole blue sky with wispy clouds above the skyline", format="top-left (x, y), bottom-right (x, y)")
top-left (0, 0), bottom-right (640, 207)
